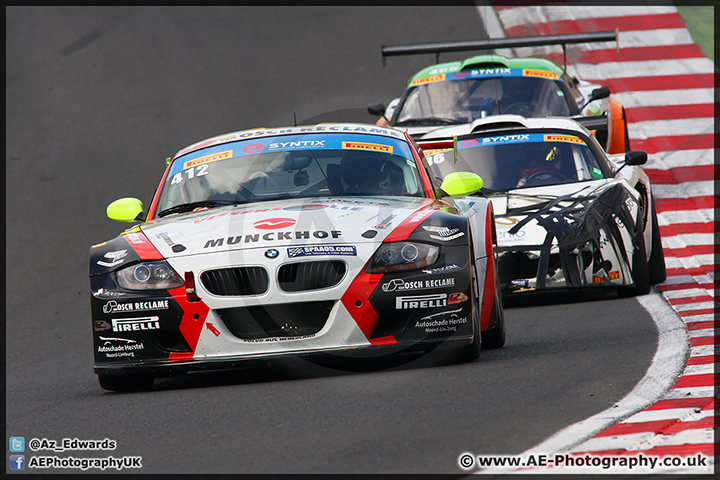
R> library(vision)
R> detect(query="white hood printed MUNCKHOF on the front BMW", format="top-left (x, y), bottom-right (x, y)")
top-left (140, 197), bottom-right (433, 258)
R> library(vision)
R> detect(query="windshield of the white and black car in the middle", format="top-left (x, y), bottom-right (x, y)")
top-left (424, 132), bottom-right (603, 192)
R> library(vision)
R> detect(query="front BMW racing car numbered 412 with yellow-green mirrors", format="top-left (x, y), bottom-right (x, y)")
top-left (90, 124), bottom-right (505, 390)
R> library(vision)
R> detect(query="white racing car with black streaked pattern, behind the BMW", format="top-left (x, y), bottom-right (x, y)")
top-left (418, 115), bottom-right (666, 295)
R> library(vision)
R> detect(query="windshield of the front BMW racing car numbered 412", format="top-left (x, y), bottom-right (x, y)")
top-left (157, 134), bottom-right (424, 216)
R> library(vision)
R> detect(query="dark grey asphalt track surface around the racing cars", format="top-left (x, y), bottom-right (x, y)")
top-left (5, 7), bottom-right (657, 473)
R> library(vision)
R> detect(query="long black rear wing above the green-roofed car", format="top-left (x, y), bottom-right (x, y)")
top-left (382, 28), bottom-right (620, 69)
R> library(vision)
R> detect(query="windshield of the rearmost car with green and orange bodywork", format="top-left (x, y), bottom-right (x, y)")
top-left (393, 73), bottom-right (570, 126)
